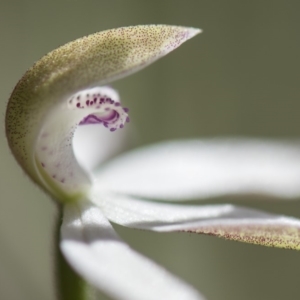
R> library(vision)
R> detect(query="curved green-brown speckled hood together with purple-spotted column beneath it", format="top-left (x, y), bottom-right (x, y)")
top-left (6, 25), bottom-right (200, 201)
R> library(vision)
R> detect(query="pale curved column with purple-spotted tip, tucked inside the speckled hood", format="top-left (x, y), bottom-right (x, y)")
top-left (36, 87), bottom-right (129, 198)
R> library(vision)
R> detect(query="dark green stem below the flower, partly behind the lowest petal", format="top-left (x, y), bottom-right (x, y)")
top-left (55, 205), bottom-right (95, 300)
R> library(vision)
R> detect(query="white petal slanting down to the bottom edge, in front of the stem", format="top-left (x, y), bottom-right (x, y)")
top-left (61, 203), bottom-right (203, 300)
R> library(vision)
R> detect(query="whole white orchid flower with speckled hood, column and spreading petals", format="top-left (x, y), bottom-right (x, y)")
top-left (6, 25), bottom-right (300, 300)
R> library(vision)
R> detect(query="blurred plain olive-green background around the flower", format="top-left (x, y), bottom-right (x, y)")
top-left (0, 0), bottom-right (300, 300)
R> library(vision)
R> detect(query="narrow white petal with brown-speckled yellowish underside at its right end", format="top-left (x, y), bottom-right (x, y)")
top-left (94, 195), bottom-right (300, 250)
